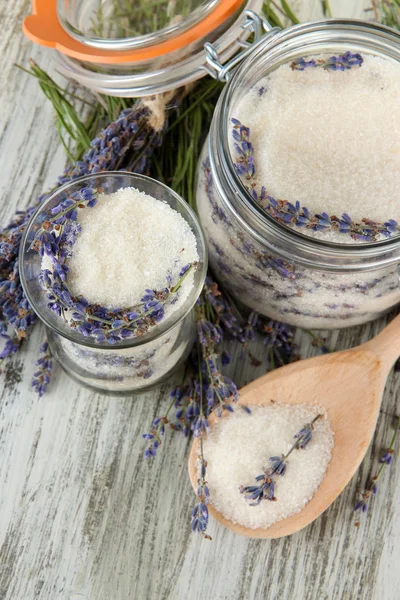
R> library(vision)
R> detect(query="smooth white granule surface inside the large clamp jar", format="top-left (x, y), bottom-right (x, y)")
top-left (232, 54), bottom-right (400, 226)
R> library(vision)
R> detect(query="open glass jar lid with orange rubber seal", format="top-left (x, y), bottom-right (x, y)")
top-left (23, 0), bottom-right (262, 97)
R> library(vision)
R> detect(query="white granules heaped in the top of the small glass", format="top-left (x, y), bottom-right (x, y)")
top-left (68, 188), bottom-right (198, 309)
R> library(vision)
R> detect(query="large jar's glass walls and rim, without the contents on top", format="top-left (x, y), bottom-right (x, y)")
top-left (197, 20), bottom-right (400, 329)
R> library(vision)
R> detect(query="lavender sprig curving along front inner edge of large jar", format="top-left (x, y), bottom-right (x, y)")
top-left (232, 119), bottom-right (400, 242)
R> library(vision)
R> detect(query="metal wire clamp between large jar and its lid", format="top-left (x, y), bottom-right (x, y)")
top-left (204, 10), bottom-right (280, 83)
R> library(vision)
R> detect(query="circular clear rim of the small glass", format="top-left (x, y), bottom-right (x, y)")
top-left (19, 171), bottom-right (208, 351)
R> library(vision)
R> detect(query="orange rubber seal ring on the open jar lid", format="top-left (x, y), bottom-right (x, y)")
top-left (22, 0), bottom-right (243, 64)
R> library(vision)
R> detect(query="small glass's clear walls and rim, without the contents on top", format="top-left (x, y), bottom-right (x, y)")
top-left (19, 171), bottom-right (207, 393)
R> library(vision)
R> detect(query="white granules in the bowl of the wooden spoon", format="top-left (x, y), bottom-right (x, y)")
top-left (204, 404), bottom-right (333, 529)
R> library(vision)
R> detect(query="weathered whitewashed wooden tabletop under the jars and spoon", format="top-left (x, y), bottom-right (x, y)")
top-left (0, 0), bottom-right (400, 600)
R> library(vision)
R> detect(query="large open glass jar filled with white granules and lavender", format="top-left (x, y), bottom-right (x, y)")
top-left (197, 20), bottom-right (400, 328)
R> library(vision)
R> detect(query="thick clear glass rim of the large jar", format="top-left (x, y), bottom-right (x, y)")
top-left (209, 19), bottom-right (400, 271)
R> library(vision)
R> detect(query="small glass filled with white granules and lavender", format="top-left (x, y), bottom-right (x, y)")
top-left (20, 172), bottom-right (207, 393)
